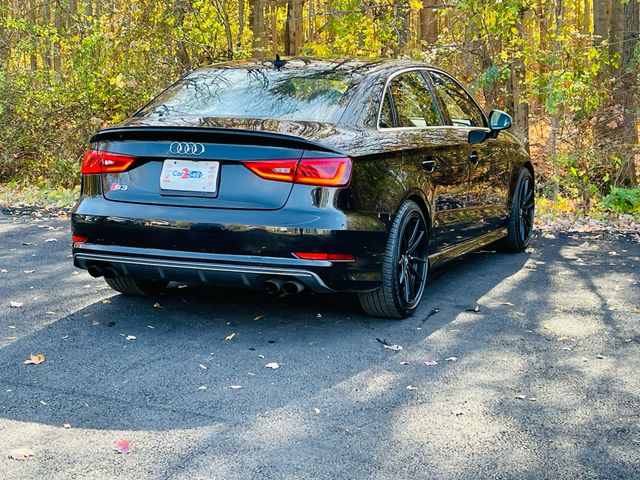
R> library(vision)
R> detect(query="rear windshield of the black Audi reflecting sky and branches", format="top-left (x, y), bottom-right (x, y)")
top-left (136, 69), bottom-right (357, 122)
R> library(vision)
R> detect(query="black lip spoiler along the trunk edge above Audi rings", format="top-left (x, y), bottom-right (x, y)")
top-left (90, 126), bottom-right (342, 153)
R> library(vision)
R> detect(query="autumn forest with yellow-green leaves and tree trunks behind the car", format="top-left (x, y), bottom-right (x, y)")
top-left (0, 0), bottom-right (640, 215)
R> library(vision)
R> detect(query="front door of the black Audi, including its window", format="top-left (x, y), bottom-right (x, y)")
top-left (429, 69), bottom-right (510, 236)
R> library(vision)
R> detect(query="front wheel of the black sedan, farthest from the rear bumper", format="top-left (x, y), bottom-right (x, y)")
top-left (496, 168), bottom-right (535, 253)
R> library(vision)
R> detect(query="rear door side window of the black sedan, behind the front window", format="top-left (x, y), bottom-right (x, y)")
top-left (381, 71), bottom-right (441, 127)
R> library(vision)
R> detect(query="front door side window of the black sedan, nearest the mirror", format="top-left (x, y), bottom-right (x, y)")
top-left (429, 71), bottom-right (486, 127)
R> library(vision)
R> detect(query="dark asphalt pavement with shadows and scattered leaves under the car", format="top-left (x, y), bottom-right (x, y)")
top-left (0, 215), bottom-right (640, 480)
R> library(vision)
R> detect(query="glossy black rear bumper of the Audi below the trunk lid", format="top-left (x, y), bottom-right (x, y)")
top-left (72, 198), bottom-right (387, 293)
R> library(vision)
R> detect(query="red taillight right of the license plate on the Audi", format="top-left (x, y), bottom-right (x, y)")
top-left (243, 157), bottom-right (351, 187)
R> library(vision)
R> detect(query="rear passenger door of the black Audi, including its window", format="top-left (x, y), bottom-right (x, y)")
top-left (379, 69), bottom-right (469, 250)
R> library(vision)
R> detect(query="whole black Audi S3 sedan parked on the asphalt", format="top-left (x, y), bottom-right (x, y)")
top-left (72, 59), bottom-right (534, 318)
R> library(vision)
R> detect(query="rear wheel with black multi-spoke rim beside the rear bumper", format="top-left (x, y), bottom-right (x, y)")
top-left (358, 200), bottom-right (429, 318)
